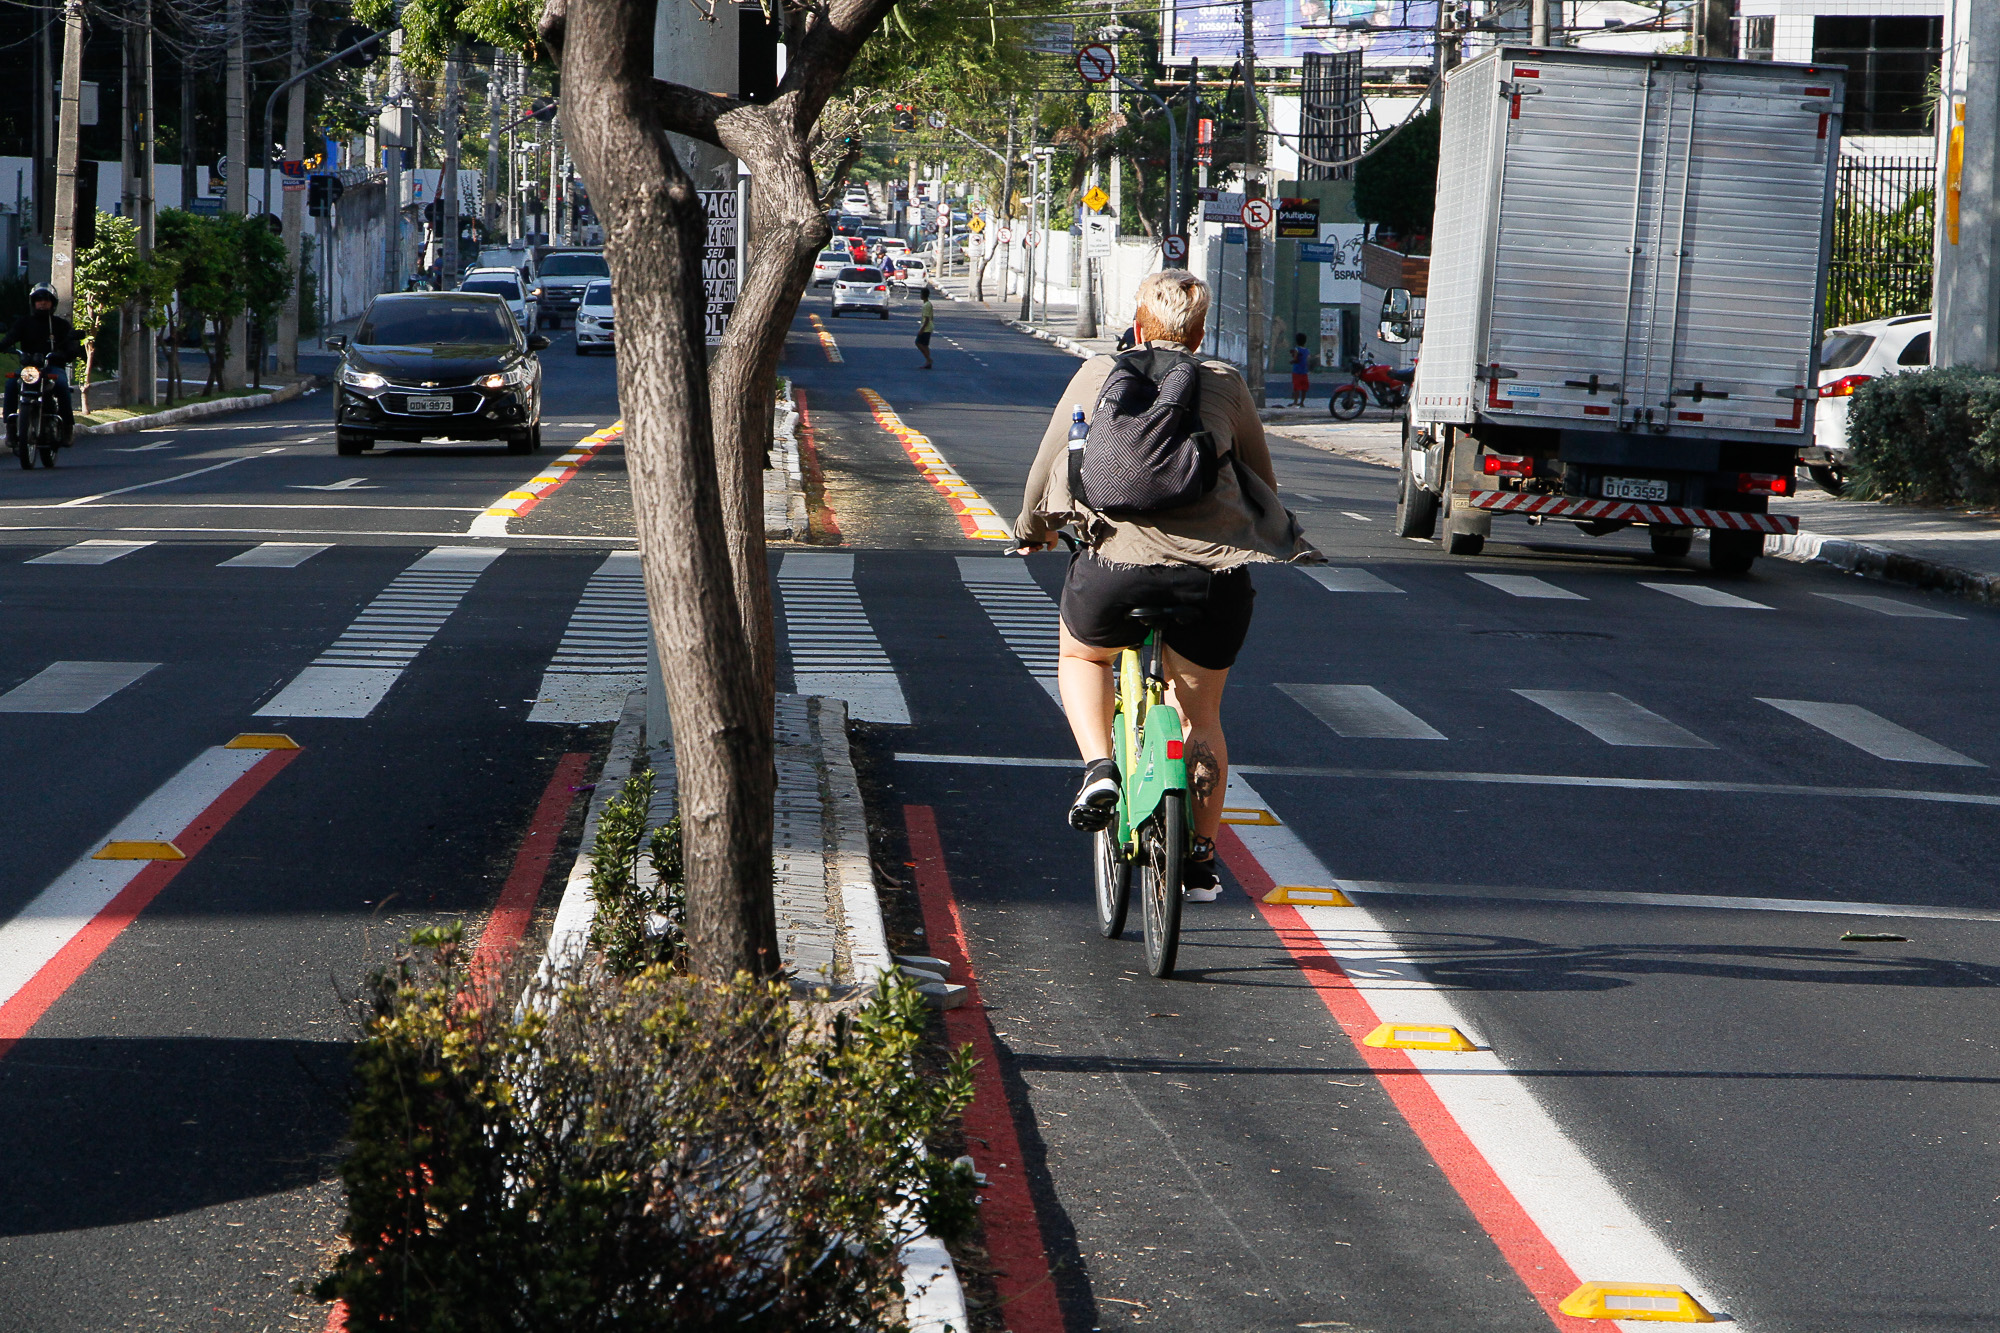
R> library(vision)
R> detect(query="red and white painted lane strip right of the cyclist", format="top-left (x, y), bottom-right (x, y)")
top-left (1216, 773), bottom-right (1742, 1333)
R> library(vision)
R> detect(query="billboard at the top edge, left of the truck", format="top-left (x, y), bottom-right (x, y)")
top-left (1160, 0), bottom-right (1438, 66)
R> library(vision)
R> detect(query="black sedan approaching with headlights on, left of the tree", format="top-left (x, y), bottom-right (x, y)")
top-left (326, 292), bottom-right (548, 454)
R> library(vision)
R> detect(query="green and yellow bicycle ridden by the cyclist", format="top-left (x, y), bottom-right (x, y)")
top-left (1092, 606), bottom-right (1196, 977)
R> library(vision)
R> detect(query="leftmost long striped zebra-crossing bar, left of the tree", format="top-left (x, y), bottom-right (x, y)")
top-left (256, 546), bottom-right (502, 717)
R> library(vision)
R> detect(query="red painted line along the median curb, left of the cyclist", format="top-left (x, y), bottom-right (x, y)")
top-left (902, 805), bottom-right (1062, 1333)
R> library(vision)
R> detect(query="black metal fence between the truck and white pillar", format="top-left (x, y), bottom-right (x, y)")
top-left (1826, 158), bottom-right (1938, 328)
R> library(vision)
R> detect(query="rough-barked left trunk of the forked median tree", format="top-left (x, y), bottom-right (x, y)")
top-left (568, 0), bottom-right (778, 964)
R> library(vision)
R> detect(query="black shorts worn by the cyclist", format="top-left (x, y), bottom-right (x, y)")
top-left (1062, 550), bottom-right (1256, 671)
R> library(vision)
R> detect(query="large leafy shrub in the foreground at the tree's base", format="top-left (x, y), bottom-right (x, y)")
top-left (318, 929), bottom-right (972, 1333)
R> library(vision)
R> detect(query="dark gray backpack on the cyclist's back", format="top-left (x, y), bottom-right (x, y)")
top-left (1070, 346), bottom-right (1216, 518)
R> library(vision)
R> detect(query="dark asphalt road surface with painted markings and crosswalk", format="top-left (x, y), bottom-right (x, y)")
top-left (0, 294), bottom-right (2000, 1333)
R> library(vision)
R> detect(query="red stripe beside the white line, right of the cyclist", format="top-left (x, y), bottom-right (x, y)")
top-left (1216, 825), bottom-right (1604, 1333)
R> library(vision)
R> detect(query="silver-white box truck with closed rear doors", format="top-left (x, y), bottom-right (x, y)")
top-left (1382, 46), bottom-right (1844, 572)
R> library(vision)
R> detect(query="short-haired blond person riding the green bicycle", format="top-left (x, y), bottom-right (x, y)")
top-left (1014, 268), bottom-right (1326, 903)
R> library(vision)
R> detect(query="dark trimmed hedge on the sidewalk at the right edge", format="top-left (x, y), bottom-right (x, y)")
top-left (1848, 366), bottom-right (2000, 506)
